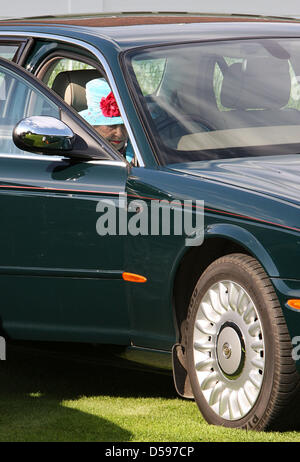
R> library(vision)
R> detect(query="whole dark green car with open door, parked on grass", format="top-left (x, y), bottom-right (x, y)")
top-left (0, 15), bottom-right (300, 430)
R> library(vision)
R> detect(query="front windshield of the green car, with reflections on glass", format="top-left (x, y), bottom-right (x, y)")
top-left (126, 38), bottom-right (300, 164)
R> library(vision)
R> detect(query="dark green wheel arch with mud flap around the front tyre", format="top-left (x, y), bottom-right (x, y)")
top-left (172, 224), bottom-right (279, 398)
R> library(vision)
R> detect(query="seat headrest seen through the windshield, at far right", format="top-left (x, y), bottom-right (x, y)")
top-left (221, 58), bottom-right (291, 109)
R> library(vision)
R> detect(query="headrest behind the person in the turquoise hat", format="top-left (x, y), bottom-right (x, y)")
top-left (52, 69), bottom-right (102, 112)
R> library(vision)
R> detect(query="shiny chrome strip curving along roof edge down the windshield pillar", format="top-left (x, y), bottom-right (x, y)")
top-left (0, 31), bottom-right (145, 167)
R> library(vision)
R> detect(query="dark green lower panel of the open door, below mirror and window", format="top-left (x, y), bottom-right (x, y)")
top-left (0, 157), bottom-right (129, 343)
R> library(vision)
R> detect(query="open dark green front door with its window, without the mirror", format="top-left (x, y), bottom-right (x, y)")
top-left (0, 59), bottom-right (129, 344)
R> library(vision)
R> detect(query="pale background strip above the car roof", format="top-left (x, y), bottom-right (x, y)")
top-left (0, 0), bottom-right (300, 18)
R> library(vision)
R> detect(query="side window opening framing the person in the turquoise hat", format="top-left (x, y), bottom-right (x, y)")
top-left (39, 58), bottom-right (132, 162)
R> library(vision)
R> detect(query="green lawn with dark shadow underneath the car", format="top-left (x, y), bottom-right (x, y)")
top-left (0, 348), bottom-right (300, 442)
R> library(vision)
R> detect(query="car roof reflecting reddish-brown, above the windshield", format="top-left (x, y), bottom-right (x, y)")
top-left (0, 13), bottom-right (300, 49)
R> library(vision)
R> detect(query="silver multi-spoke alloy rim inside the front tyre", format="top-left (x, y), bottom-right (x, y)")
top-left (193, 280), bottom-right (265, 420)
